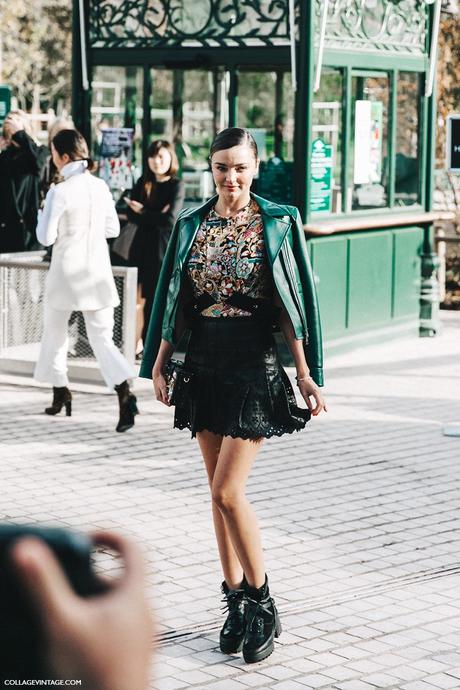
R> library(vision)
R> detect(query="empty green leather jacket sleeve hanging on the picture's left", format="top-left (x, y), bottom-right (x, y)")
top-left (139, 215), bottom-right (180, 379)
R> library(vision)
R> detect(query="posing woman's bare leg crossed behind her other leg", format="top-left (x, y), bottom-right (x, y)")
top-left (196, 431), bottom-right (243, 589)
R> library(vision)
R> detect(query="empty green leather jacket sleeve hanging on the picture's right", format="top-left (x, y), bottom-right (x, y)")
top-left (292, 204), bottom-right (324, 386)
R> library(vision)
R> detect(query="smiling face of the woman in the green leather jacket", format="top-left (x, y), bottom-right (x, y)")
top-left (211, 144), bottom-right (259, 203)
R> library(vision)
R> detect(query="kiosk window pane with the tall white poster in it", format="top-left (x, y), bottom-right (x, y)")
top-left (347, 75), bottom-right (389, 209)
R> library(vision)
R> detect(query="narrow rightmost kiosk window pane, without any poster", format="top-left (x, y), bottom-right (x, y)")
top-left (395, 72), bottom-right (420, 206)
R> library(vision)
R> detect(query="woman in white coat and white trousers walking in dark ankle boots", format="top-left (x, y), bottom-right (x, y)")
top-left (34, 129), bottom-right (137, 431)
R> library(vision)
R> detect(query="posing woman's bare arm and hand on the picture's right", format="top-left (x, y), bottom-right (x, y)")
top-left (274, 291), bottom-right (327, 417)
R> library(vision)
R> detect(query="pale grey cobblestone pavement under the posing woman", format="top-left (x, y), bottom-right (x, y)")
top-left (0, 314), bottom-right (460, 690)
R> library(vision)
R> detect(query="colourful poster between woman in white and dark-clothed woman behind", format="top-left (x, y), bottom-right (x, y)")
top-left (99, 127), bottom-right (134, 190)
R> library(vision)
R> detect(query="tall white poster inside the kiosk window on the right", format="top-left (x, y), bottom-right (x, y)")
top-left (353, 101), bottom-right (383, 184)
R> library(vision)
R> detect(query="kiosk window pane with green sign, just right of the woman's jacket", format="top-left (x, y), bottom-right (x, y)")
top-left (310, 68), bottom-right (343, 213)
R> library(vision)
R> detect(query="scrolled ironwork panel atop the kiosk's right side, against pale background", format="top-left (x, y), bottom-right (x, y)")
top-left (315, 0), bottom-right (427, 55)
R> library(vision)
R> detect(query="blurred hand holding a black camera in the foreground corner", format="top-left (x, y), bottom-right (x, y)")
top-left (0, 528), bottom-right (153, 690)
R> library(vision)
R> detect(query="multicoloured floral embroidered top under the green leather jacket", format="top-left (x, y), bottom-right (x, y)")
top-left (187, 199), bottom-right (273, 317)
